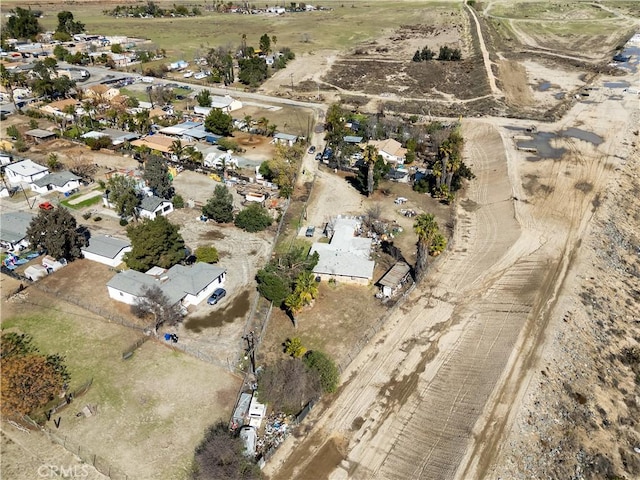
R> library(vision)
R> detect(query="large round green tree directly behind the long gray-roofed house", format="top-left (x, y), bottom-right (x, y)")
top-left (124, 216), bottom-right (185, 272)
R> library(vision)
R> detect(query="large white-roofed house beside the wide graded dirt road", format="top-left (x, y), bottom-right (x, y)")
top-left (309, 217), bottom-right (375, 285)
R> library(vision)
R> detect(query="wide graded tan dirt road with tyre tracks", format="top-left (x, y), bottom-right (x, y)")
top-left (265, 77), bottom-right (637, 479)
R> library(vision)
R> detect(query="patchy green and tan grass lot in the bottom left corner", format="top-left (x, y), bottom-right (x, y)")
top-left (2, 286), bottom-right (241, 479)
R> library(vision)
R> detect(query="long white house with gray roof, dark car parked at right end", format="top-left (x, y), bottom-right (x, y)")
top-left (107, 262), bottom-right (226, 307)
